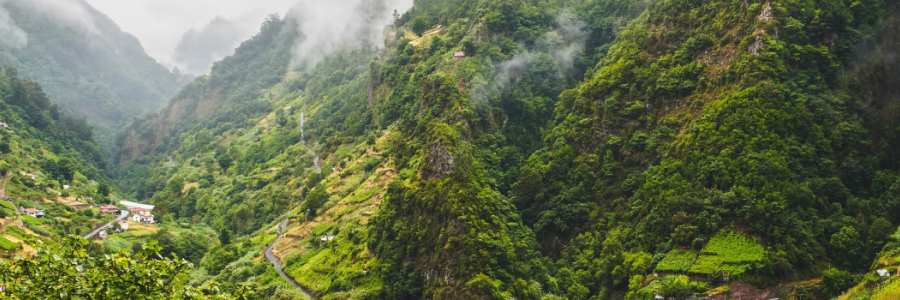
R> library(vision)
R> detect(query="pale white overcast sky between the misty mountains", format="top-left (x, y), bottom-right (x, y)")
top-left (87, 0), bottom-right (297, 65)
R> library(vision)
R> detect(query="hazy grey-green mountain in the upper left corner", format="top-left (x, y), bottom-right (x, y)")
top-left (0, 0), bottom-right (188, 156)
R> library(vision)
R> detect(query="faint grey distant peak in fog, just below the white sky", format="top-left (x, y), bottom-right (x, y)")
top-left (172, 16), bottom-right (246, 74)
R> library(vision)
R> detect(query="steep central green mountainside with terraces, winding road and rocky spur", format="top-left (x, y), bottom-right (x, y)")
top-left (112, 2), bottom-right (642, 298)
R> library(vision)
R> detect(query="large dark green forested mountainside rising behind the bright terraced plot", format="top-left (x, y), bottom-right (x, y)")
top-left (512, 1), bottom-right (900, 295)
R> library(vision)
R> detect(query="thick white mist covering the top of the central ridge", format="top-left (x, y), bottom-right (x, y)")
top-left (287, 0), bottom-right (413, 70)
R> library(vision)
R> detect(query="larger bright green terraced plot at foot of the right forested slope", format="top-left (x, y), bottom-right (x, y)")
top-left (690, 230), bottom-right (766, 276)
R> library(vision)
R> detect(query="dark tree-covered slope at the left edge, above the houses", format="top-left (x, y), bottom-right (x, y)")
top-left (0, 68), bottom-right (108, 200)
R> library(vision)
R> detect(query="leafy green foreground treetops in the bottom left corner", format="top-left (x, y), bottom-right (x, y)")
top-left (0, 236), bottom-right (245, 299)
